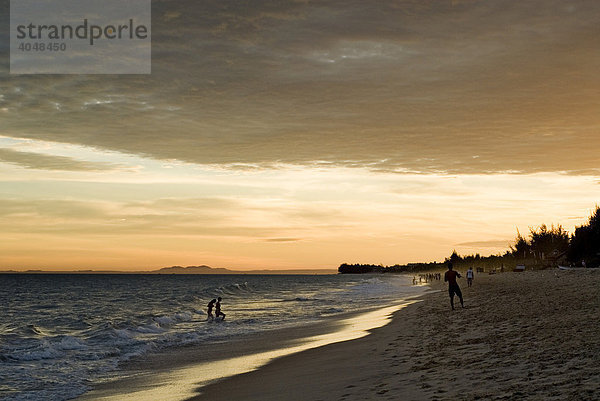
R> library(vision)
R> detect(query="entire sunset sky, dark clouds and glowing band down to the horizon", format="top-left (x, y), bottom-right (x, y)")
top-left (0, 0), bottom-right (600, 270)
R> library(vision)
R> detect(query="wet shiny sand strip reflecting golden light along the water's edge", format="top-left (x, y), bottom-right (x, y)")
top-left (77, 286), bottom-right (427, 401)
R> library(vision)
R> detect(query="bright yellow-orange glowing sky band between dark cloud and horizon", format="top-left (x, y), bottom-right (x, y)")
top-left (0, 142), bottom-right (598, 270)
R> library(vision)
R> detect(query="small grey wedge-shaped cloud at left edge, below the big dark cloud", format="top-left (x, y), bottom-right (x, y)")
top-left (0, 148), bottom-right (119, 171)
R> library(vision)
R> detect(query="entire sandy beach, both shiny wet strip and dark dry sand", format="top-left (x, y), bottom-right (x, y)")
top-left (79, 269), bottom-right (600, 401)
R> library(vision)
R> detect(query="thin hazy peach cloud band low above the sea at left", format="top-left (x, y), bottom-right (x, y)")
top-left (0, 197), bottom-right (343, 242)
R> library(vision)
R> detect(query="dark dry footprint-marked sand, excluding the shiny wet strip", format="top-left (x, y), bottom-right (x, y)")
top-left (193, 269), bottom-right (600, 401)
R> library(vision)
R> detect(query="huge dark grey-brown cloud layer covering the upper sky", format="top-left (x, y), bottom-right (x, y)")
top-left (0, 0), bottom-right (600, 174)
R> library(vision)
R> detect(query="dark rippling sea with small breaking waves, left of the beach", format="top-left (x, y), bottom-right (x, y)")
top-left (0, 274), bottom-right (423, 400)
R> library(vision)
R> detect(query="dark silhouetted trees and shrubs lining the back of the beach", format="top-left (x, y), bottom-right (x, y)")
top-left (338, 206), bottom-right (600, 274)
